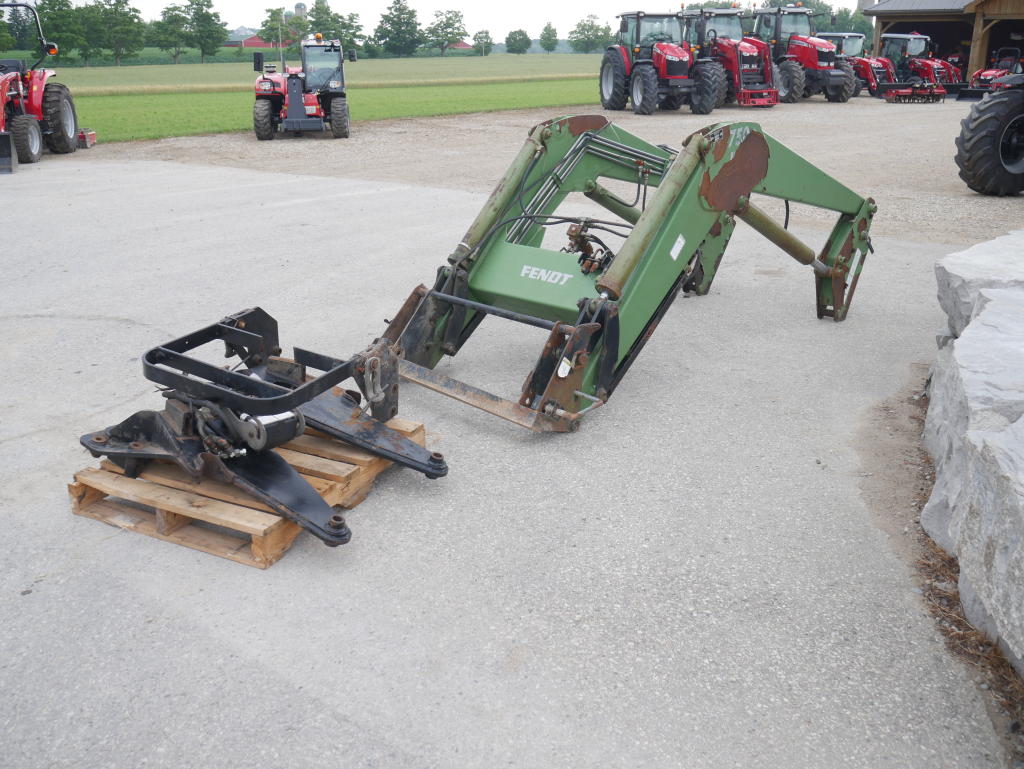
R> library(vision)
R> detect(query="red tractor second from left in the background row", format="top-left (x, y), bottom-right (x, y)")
top-left (683, 7), bottom-right (778, 106)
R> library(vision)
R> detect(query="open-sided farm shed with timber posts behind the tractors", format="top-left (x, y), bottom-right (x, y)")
top-left (863, 0), bottom-right (1024, 73)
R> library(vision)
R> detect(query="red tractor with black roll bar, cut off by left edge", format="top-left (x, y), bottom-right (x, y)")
top-left (0, 2), bottom-right (79, 173)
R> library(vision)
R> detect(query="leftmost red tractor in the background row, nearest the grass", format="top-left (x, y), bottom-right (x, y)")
top-left (600, 11), bottom-right (727, 115)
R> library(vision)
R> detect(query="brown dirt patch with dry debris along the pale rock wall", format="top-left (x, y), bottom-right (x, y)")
top-left (857, 365), bottom-right (1024, 768)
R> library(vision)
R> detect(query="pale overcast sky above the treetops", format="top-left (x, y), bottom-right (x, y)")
top-left (125, 0), bottom-right (854, 41)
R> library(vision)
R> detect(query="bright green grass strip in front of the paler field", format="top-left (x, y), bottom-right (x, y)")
top-left (75, 78), bottom-right (597, 141)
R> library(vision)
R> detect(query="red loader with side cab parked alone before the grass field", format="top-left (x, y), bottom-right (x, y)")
top-left (253, 33), bottom-right (355, 140)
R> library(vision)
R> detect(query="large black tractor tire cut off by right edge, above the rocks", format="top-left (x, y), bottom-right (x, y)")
top-left (955, 88), bottom-right (1024, 197)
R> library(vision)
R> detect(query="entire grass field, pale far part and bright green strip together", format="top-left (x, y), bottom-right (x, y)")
top-left (57, 54), bottom-right (600, 141)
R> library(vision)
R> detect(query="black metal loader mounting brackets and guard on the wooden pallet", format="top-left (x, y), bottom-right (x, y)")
top-left (81, 307), bottom-right (447, 546)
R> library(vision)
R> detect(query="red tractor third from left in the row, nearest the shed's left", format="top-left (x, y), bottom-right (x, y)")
top-left (754, 4), bottom-right (856, 103)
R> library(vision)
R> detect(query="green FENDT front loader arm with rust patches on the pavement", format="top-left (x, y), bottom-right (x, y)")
top-left (384, 116), bottom-right (877, 431)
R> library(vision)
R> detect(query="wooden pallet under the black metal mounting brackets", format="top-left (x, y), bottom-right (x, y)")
top-left (68, 419), bottom-right (426, 568)
